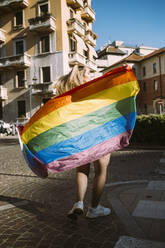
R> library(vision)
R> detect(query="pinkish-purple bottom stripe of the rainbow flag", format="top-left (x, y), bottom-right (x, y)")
top-left (47, 130), bottom-right (133, 173)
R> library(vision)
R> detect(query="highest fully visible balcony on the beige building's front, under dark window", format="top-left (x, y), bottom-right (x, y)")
top-left (29, 14), bottom-right (56, 33)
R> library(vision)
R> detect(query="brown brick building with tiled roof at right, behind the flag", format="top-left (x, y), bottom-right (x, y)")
top-left (102, 48), bottom-right (165, 114)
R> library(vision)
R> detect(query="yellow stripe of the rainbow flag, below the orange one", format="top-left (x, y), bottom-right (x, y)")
top-left (21, 81), bottom-right (139, 144)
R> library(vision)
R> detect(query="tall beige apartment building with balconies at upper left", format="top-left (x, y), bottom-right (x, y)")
top-left (0, 0), bottom-right (97, 122)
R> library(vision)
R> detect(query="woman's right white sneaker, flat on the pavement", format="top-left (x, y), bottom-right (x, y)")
top-left (86, 205), bottom-right (111, 218)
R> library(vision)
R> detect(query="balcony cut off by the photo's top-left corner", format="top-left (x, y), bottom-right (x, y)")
top-left (0, 0), bottom-right (29, 11)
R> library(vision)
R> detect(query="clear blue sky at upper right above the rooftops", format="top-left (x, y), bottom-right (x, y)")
top-left (92, 0), bottom-right (165, 49)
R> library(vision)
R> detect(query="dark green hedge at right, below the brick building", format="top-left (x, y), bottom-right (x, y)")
top-left (130, 114), bottom-right (165, 145)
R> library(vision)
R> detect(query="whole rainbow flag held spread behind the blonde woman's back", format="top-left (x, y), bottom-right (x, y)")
top-left (19, 65), bottom-right (139, 178)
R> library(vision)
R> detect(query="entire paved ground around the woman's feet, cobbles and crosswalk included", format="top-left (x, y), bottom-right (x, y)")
top-left (0, 138), bottom-right (165, 248)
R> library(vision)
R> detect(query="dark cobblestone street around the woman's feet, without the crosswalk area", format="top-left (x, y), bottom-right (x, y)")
top-left (0, 138), bottom-right (165, 248)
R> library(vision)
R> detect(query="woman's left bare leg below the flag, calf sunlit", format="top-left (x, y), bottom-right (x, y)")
top-left (76, 164), bottom-right (90, 201)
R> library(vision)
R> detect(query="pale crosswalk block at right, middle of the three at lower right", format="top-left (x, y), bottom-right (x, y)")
top-left (132, 200), bottom-right (165, 219)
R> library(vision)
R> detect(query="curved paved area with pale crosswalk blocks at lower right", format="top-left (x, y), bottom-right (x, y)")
top-left (107, 180), bottom-right (165, 248)
